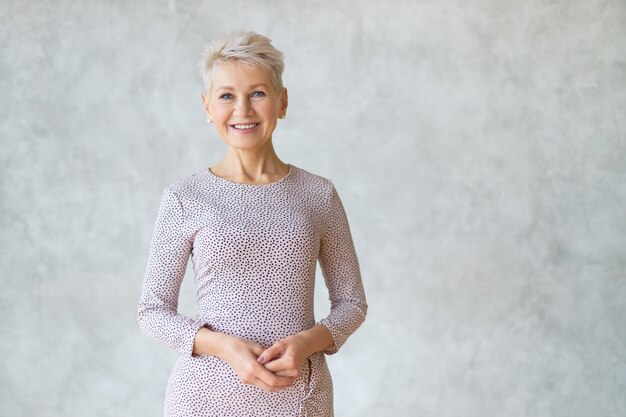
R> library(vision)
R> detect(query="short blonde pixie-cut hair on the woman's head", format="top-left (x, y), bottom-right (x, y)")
top-left (198, 30), bottom-right (285, 94)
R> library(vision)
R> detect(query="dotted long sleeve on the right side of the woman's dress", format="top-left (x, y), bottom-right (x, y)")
top-left (317, 182), bottom-right (368, 355)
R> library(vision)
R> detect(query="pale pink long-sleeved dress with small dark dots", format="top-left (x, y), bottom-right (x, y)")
top-left (137, 164), bottom-right (368, 417)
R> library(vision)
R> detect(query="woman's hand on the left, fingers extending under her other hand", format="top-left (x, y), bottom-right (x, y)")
top-left (220, 334), bottom-right (296, 392)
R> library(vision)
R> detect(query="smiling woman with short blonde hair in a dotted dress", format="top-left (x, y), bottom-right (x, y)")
top-left (137, 32), bottom-right (367, 417)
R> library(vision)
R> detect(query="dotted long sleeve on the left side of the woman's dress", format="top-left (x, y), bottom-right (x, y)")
top-left (137, 187), bottom-right (206, 356)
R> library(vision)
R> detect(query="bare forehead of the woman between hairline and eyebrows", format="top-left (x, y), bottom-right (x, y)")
top-left (212, 61), bottom-right (272, 91)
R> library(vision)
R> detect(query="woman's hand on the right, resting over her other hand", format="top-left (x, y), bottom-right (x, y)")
top-left (257, 335), bottom-right (310, 378)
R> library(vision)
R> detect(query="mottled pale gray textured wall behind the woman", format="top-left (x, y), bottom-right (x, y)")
top-left (0, 0), bottom-right (626, 417)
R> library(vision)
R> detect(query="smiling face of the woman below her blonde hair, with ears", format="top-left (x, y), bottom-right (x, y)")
top-left (202, 62), bottom-right (287, 149)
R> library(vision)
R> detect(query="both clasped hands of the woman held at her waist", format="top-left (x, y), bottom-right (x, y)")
top-left (222, 335), bottom-right (311, 392)
